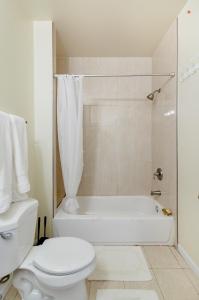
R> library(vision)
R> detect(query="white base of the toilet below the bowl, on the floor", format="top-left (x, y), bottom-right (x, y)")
top-left (13, 270), bottom-right (88, 300)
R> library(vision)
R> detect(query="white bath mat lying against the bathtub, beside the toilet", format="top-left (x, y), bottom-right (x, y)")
top-left (89, 246), bottom-right (152, 281)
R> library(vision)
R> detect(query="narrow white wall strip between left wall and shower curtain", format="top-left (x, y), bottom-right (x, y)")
top-left (33, 21), bottom-right (55, 234)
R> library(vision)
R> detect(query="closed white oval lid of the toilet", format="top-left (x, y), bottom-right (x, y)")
top-left (33, 237), bottom-right (95, 275)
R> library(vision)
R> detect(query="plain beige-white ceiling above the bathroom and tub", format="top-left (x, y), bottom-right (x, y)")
top-left (22, 0), bottom-right (187, 56)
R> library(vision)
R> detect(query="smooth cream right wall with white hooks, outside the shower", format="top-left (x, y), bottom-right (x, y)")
top-left (178, 0), bottom-right (199, 268)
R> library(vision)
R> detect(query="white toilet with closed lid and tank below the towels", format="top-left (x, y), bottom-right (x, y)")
top-left (0, 199), bottom-right (95, 300)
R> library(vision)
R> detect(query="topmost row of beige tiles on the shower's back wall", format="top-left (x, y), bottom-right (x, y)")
top-left (68, 57), bottom-right (151, 101)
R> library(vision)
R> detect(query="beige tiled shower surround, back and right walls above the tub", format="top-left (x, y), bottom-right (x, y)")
top-left (58, 42), bottom-right (176, 212)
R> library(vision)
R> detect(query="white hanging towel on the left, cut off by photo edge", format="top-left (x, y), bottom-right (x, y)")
top-left (0, 112), bottom-right (13, 214)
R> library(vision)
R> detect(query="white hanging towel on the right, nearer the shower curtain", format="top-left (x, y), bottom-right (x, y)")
top-left (10, 115), bottom-right (30, 195)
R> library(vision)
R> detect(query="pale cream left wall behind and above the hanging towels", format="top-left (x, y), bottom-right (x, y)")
top-left (0, 0), bottom-right (34, 195)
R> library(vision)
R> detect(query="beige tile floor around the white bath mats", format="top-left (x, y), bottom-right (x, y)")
top-left (5, 246), bottom-right (199, 300)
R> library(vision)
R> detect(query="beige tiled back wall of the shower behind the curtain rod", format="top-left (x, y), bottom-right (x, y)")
top-left (57, 57), bottom-right (152, 200)
